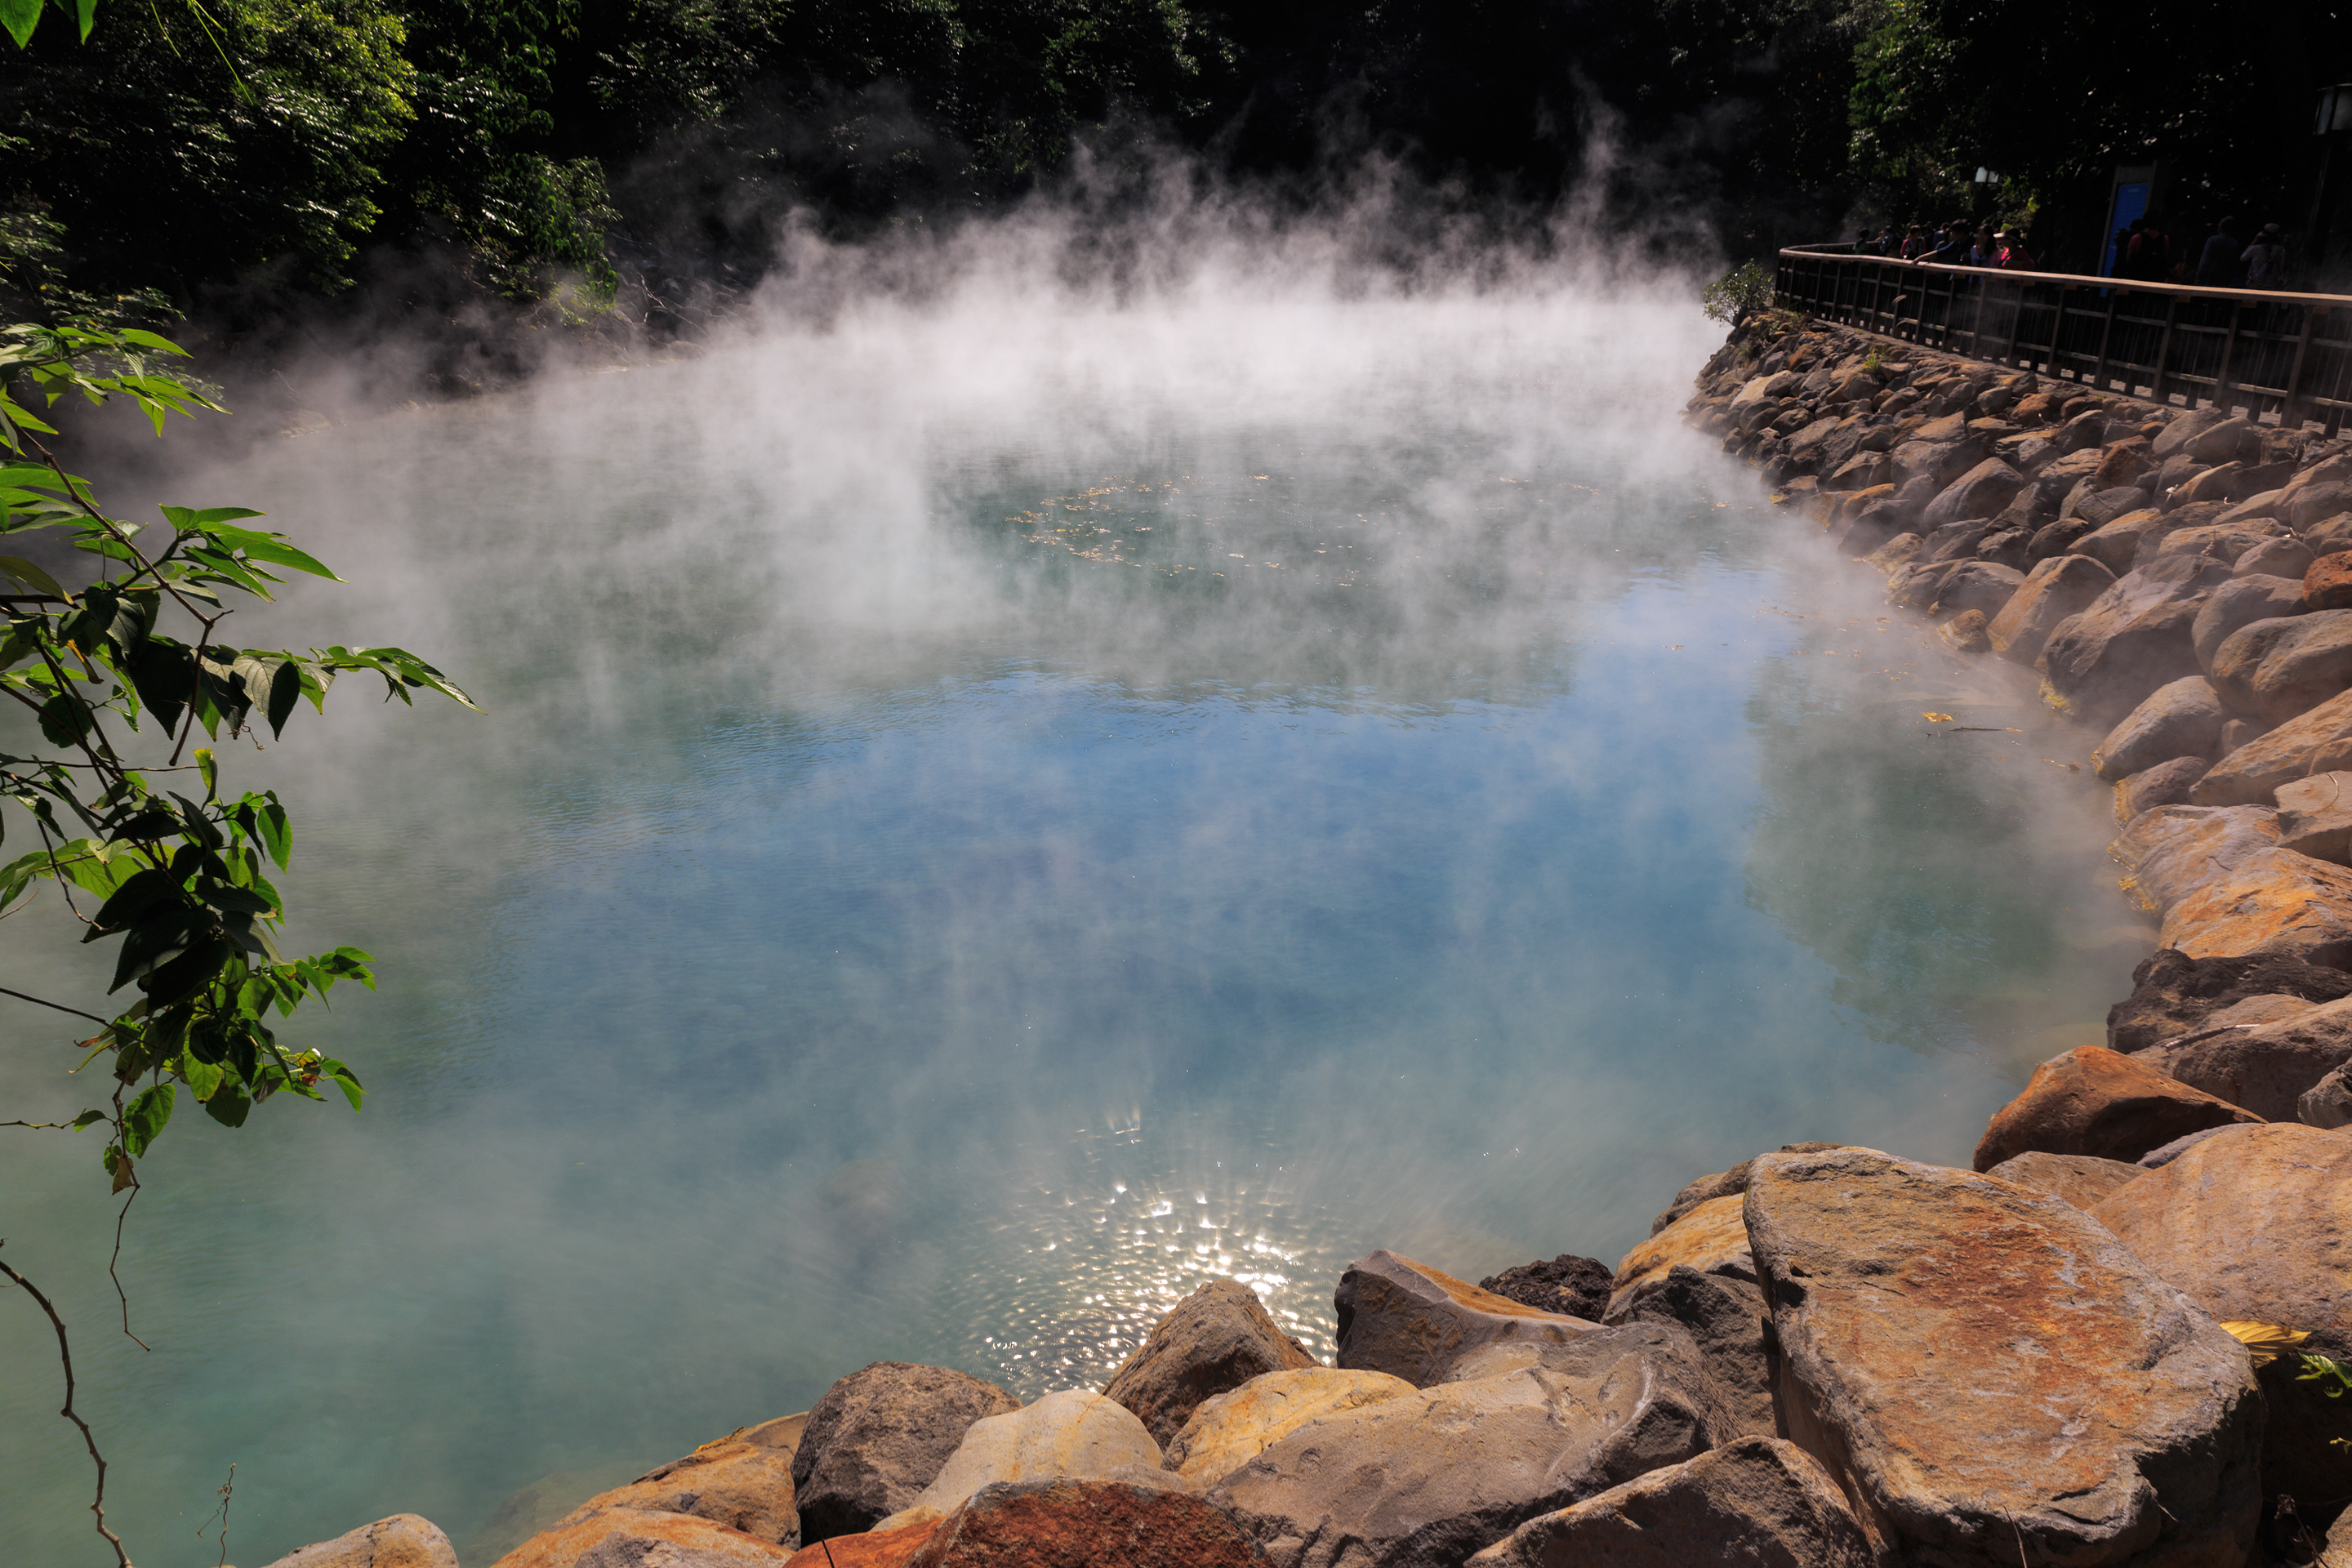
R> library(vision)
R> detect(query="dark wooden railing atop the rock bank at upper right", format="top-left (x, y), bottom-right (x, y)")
top-left (1774, 244), bottom-right (2352, 435)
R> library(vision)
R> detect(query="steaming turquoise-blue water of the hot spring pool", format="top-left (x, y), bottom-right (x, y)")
top-left (0, 294), bottom-right (2149, 1568)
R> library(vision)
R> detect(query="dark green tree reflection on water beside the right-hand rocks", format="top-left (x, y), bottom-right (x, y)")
top-left (1745, 658), bottom-right (2147, 1055)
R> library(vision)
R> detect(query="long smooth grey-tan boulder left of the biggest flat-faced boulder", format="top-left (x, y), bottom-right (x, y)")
top-left (1209, 1324), bottom-right (1724, 1568)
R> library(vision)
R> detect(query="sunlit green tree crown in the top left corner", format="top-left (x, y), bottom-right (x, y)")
top-left (0, 0), bottom-right (414, 301)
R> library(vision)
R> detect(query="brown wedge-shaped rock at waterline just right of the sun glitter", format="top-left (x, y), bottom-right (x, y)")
top-left (1331, 1249), bottom-right (1592, 1387)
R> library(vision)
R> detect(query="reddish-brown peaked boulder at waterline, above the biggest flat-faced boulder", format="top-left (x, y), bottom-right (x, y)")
top-left (1976, 1046), bottom-right (2261, 1170)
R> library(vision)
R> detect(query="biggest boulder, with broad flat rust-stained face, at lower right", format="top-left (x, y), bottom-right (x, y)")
top-left (1748, 1142), bottom-right (2263, 1568)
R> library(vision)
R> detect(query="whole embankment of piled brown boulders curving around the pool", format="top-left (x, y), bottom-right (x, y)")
top-left (252, 322), bottom-right (2352, 1568)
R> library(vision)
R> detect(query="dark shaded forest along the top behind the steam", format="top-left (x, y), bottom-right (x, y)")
top-left (0, 0), bottom-right (2352, 404)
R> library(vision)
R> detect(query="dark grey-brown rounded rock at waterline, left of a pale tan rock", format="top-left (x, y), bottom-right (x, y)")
top-left (793, 1361), bottom-right (1021, 1542)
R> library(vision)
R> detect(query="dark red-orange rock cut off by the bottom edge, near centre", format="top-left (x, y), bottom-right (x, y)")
top-left (908, 1481), bottom-right (1265, 1568)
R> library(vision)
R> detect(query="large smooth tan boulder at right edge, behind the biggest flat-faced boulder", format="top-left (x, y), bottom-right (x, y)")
top-left (2091, 1124), bottom-right (2352, 1502)
